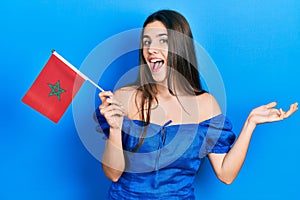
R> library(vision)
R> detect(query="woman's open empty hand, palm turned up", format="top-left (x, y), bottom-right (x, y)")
top-left (248, 102), bottom-right (298, 125)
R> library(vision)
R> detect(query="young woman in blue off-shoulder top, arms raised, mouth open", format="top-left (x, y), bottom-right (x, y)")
top-left (99, 10), bottom-right (298, 199)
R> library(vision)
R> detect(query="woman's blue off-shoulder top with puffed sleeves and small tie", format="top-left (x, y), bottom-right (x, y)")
top-left (98, 114), bottom-right (235, 200)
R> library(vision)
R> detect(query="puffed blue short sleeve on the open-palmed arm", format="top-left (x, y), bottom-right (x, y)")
top-left (202, 114), bottom-right (236, 155)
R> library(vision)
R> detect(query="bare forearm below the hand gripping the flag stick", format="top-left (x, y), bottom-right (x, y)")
top-left (102, 129), bottom-right (125, 182)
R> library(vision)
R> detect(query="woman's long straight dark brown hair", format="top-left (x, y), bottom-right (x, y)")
top-left (133, 10), bottom-right (205, 152)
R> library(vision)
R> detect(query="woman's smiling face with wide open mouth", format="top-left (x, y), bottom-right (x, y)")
top-left (142, 21), bottom-right (168, 83)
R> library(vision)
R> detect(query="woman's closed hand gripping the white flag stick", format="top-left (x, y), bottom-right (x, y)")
top-left (99, 91), bottom-right (126, 130)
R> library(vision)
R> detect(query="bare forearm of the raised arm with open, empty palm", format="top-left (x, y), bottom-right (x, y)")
top-left (220, 118), bottom-right (256, 184)
